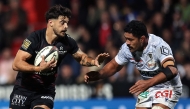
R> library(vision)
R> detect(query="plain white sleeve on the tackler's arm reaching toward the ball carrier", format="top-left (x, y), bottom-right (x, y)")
top-left (115, 43), bottom-right (131, 65)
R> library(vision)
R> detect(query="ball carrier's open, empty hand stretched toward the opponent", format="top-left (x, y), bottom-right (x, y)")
top-left (94, 53), bottom-right (110, 67)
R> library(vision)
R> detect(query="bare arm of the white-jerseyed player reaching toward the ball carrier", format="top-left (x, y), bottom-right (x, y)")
top-left (84, 58), bottom-right (123, 83)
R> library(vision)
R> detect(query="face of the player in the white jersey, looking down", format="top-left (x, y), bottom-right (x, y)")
top-left (124, 32), bottom-right (142, 52)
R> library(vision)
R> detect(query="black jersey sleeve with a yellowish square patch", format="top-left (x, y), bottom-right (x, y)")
top-left (20, 32), bottom-right (37, 55)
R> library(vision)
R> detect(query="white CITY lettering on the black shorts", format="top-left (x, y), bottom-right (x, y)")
top-left (11, 94), bottom-right (27, 106)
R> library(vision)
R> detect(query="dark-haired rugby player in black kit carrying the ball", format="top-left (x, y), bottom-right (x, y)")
top-left (9, 5), bottom-right (109, 109)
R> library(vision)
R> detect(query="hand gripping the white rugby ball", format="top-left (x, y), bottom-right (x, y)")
top-left (39, 56), bottom-right (57, 72)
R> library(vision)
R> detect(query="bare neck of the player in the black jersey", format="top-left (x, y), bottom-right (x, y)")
top-left (46, 28), bottom-right (58, 44)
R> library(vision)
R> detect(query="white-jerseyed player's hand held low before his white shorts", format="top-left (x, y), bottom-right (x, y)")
top-left (129, 80), bottom-right (150, 95)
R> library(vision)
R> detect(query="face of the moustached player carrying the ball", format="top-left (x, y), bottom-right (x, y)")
top-left (53, 16), bottom-right (69, 37)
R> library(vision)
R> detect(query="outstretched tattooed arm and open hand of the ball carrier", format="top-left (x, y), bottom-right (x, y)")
top-left (73, 49), bottom-right (109, 67)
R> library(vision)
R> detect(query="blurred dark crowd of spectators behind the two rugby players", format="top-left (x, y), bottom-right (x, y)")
top-left (0, 0), bottom-right (190, 97)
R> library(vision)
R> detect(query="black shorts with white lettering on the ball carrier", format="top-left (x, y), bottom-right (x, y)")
top-left (9, 87), bottom-right (55, 109)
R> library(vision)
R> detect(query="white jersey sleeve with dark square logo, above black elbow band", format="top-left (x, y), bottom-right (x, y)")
top-left (156, 41), bottom-right (174, 63)
